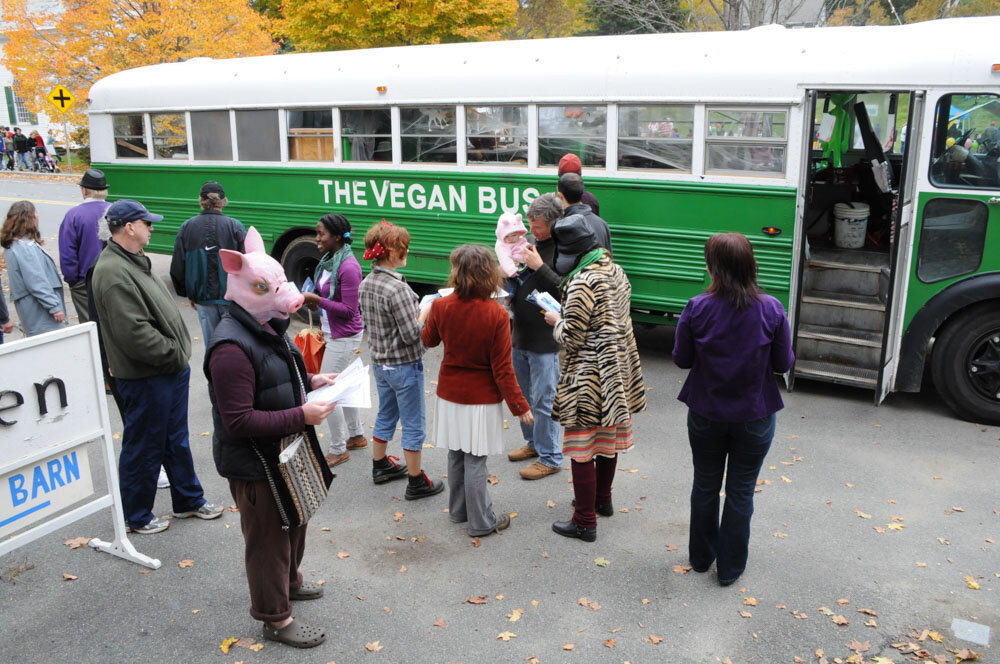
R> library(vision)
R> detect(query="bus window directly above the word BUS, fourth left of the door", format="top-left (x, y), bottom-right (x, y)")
top-left (465, 106), bottom-right (528, 166)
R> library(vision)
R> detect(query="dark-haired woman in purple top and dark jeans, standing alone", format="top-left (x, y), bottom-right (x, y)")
top-left (673, 233), bottom-right (795, 586)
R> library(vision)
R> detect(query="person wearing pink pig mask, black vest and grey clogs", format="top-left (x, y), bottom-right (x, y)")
top-left (204, 227), bottom-right (336, 648)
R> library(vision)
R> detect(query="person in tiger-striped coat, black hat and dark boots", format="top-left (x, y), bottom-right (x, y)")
top-left (545, 215), bottom-right (646, 542)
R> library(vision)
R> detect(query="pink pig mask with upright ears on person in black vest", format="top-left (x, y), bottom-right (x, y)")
top-left (219, 226), bottom-right (305, 323)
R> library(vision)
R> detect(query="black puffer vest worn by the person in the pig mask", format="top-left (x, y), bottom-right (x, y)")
top-left (204, 303), bottom-right (308, 481)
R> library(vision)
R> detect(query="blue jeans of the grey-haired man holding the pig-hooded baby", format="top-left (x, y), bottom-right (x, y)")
top-left (511, 348), bottom-right (562, 468)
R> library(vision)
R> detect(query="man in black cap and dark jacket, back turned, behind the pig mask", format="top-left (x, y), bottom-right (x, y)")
top-left (170, 181), bottom-right (247, 348)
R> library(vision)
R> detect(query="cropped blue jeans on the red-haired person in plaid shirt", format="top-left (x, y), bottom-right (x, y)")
top-left (372, 361), bottom-right (427, 452)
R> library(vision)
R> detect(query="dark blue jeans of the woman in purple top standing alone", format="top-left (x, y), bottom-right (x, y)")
top-left (688, 410), bottom-right (776, 581)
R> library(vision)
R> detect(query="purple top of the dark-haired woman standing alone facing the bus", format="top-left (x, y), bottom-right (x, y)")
top-left (673, 293), bottom-right (795, 422)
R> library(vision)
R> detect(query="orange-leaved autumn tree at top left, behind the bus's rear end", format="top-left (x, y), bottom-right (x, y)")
top-left (2, 0), bottom-right (276, 125)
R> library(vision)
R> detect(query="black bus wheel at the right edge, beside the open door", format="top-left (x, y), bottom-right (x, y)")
top-left (931, 302), bottom-right (1000, 424)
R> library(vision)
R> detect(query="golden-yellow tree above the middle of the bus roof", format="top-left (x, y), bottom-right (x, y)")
top-left (281, 0), bottom-right (518, 51)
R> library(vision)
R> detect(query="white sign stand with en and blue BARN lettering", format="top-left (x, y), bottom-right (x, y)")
top-left (0, 323), bottom-right (160, 569)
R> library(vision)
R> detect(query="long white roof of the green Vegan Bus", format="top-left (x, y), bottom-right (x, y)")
top-left (89, 17), bottom-right (1000, 113)
